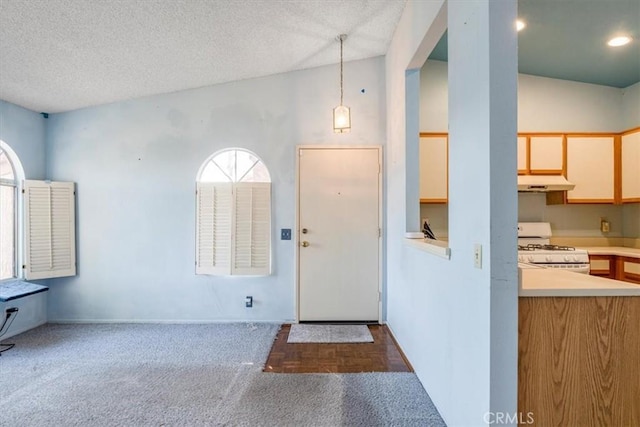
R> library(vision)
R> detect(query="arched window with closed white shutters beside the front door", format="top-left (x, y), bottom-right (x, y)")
top-left (196, 148), bottom-right (271, 275)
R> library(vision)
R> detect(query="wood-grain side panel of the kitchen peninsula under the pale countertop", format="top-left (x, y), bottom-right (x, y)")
top-left (518, 296), bottom-right (640, 427)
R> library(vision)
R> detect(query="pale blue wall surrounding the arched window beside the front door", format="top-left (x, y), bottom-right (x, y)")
top-left (47, 57), bottom-right (385, 321)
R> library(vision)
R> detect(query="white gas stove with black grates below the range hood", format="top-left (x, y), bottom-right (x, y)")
top-left (518, 222), bottom-right (589, 274)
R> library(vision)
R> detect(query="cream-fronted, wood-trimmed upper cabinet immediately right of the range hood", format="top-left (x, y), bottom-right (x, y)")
top-left (567, 135), bottom-right (615, 203)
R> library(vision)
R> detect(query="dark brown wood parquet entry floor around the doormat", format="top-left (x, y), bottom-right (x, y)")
top-left (263, 324), bottom-right (413, 373)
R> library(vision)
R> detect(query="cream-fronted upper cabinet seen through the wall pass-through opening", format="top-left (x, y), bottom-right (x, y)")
top-left (420, 135), bottom-right (449, 203)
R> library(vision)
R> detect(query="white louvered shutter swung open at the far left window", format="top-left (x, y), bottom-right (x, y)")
top-left (23, 180), bottom-right (76, 280)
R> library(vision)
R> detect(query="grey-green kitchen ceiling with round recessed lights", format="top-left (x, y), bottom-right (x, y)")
top-left (431, 0), bottom-right (640, 88)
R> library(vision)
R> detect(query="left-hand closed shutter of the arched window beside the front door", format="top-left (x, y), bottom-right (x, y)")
top-left (196, 182), bottom-right (233, 275)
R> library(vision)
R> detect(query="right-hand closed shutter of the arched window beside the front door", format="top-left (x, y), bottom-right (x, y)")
top-left (232, 182), bottom-right (271, 275)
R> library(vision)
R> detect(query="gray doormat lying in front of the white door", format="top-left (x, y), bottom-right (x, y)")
top-left (287, 323), bottom-right (373, 343)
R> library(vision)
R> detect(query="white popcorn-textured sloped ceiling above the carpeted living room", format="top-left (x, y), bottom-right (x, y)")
top-left (0, 0), bottom-right (406, 113)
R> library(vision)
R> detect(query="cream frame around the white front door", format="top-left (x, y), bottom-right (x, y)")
top-left (293, 144), bottom-right (384, 324)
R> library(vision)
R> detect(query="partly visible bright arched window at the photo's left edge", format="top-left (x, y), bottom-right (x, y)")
top-left (0, 145), bottom-right (18, 280)
